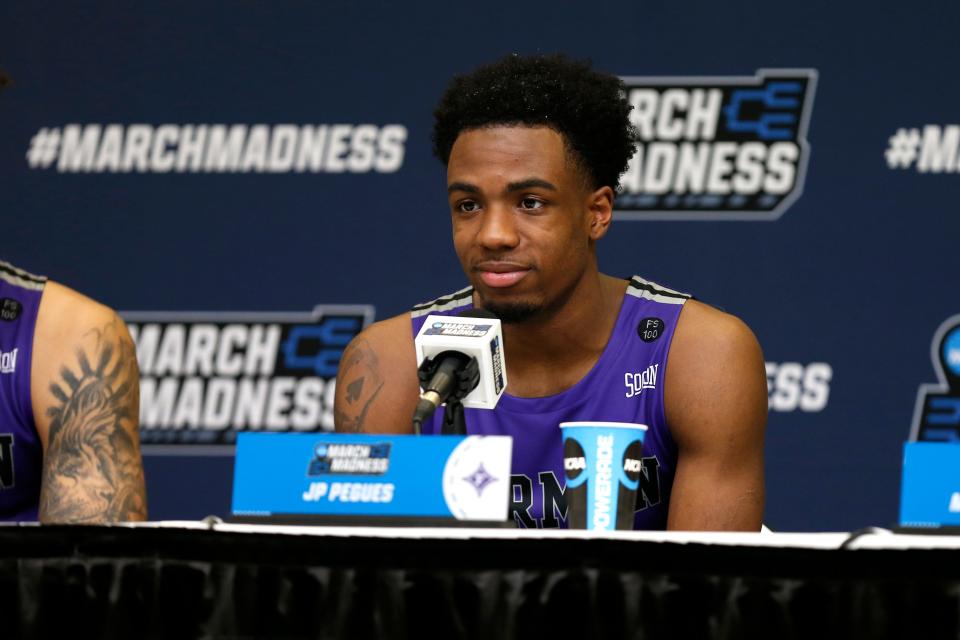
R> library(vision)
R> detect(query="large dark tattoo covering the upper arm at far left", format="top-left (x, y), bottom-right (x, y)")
top-left (40, 319), bottom-right (147, 523)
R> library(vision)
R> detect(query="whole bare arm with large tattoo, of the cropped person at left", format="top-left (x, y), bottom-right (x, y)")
top-left (31, 282), bottom-right (147, 523)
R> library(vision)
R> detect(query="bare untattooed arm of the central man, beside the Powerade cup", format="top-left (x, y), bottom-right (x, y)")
top-left (665, 302), bottom-right (767, 531)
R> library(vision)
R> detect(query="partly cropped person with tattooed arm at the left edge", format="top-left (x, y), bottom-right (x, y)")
top-left (0, 261), bottom-right (147, 523)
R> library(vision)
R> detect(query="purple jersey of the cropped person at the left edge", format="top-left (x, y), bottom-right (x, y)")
top-left (0, 261), bottom-right (46, 520)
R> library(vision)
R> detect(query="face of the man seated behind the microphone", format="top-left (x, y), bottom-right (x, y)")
top-left (447, 126), bottom-right (605, 322)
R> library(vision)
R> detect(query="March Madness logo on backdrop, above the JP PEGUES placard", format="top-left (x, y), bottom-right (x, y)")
top-left (122, 305), bottom-right (373, 445)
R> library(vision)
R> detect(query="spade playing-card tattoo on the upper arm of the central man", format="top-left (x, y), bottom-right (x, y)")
top-left (333, 338), bottom-right (383, 433)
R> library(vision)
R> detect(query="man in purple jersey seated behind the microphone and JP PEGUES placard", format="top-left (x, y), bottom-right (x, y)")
top-left (335, 55), bottom-right (767, 531)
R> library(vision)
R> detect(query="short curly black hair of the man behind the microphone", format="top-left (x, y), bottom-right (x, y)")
top-left (433, 54), bottom-right (636, 190)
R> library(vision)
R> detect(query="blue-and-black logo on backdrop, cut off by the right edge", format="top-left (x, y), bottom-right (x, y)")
top-left (910, 314), bottom-right (960, 442)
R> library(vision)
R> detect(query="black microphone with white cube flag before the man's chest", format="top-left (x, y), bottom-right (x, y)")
top-left (413, 309), bottom-right (499, 434)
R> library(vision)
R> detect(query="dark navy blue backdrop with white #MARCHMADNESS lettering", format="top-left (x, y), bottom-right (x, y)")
top-left (0, 0), bottom-right (960, 530)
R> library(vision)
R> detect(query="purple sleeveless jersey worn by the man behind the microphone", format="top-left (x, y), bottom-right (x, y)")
top-left (411, 276), bottom-right (690, 529)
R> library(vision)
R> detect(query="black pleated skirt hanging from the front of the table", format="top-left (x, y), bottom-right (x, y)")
top-left (0, 527), bottom-right (960, 640)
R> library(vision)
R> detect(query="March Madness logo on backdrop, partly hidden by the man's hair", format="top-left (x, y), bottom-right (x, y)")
top-left (616, 69), bottom-right (817, 220)
